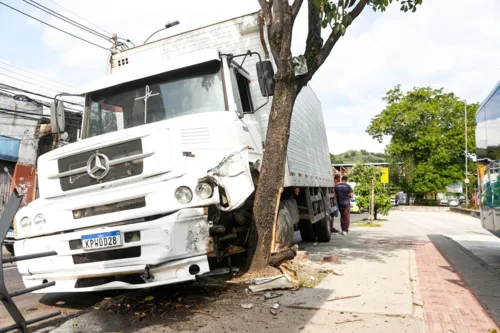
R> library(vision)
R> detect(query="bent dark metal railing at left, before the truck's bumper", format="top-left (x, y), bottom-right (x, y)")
top-left (0, 189), bottom-right (61, 333)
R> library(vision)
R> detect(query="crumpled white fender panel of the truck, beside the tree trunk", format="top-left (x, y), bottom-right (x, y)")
top-left (208, 146), bottom-right (255, 212)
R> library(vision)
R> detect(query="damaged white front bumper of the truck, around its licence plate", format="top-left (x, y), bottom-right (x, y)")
top-left (14, 208), bottom-right (213, 293)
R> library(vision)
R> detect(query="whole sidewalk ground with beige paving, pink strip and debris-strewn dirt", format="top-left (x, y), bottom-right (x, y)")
top-left (42, 212), bottom-right (500, 333)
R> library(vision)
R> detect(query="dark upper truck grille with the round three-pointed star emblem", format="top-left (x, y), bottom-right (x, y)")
top-left (56, 139), bottom-right (144, 191)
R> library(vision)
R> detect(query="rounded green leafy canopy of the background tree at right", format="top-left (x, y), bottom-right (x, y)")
top-left (367, 85), bottom-right (478, 195)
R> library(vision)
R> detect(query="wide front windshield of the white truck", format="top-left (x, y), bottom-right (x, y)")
top-left (86, 65), bottom-right (225, 137)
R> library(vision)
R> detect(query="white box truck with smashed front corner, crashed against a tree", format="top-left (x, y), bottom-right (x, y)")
top-left (14, 13), bottom-right (334, 293)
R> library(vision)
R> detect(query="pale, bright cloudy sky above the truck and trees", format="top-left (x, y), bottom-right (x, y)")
top-left (0, 0), bottom-right (500, 154)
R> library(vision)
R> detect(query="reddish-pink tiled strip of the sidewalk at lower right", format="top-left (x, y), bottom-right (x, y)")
top-left (415, 243), bottom-right (496, 333)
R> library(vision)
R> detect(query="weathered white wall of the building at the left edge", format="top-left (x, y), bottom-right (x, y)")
top-left (0, 94), bottom-right (43, 165)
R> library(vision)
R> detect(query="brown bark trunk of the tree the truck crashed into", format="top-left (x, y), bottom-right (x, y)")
top-left (248, 71), bottom-right (297, 271)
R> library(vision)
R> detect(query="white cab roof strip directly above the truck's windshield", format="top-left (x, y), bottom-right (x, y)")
top-left (79, 49), bottom-right (220, 95)
